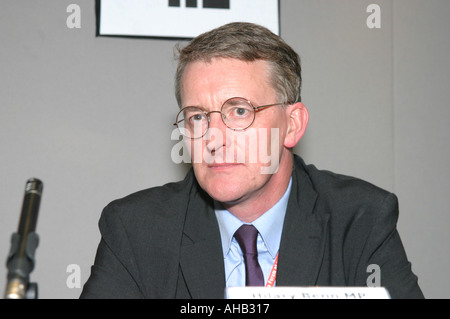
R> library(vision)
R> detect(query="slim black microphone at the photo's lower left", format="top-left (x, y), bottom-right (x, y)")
top-left (5, 178), bottom-right (43, 299)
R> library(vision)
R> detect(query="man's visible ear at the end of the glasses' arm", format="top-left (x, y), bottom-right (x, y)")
top-left (284, 102), bottom-right (309, 148)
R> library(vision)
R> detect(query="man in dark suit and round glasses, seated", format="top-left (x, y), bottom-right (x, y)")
top-left (81, 23), bottom-right (423, 298)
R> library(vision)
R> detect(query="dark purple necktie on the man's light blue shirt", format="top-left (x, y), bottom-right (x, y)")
top-left (234, 225), bottom-right (264, 286)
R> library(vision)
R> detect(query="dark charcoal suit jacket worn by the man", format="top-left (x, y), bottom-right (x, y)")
top-left (81, 156), bottom-right (423, 298)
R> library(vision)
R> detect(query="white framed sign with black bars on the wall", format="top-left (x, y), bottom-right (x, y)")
top-left (97, 0), bottom-right (280, 39)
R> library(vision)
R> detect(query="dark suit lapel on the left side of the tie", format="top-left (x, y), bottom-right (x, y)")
top-left (180, 186), bottom-right (225, 299)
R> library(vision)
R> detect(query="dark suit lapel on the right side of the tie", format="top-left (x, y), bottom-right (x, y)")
top-left (277, 158), bottom-right (329, 286)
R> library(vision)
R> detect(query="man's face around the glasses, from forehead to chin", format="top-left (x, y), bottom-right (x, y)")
top-left (182, 59), bottom-right (291, 208)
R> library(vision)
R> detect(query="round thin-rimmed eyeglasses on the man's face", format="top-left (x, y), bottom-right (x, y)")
top-left (173, 97), bottom-right (285, 139)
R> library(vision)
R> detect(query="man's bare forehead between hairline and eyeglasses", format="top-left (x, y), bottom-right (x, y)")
top-left (181, 58), bottom-right (275, 106)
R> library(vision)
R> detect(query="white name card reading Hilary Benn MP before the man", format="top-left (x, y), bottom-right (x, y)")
top-left (226, 287), bottom-right (391, 299)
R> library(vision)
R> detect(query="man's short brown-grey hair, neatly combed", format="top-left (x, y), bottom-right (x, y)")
top-left (175, 22), bottom-right (302, 107)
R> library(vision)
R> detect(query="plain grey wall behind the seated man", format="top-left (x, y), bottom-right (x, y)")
top-left (0, 0), bottom-right (450, 298)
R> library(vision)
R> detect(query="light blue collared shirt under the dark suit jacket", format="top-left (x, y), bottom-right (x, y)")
top-left (215, 178), bottom-right (292, 287)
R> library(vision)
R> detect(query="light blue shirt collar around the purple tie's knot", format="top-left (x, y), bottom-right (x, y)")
top-left (215, 178), bottom-right (292, 258)
